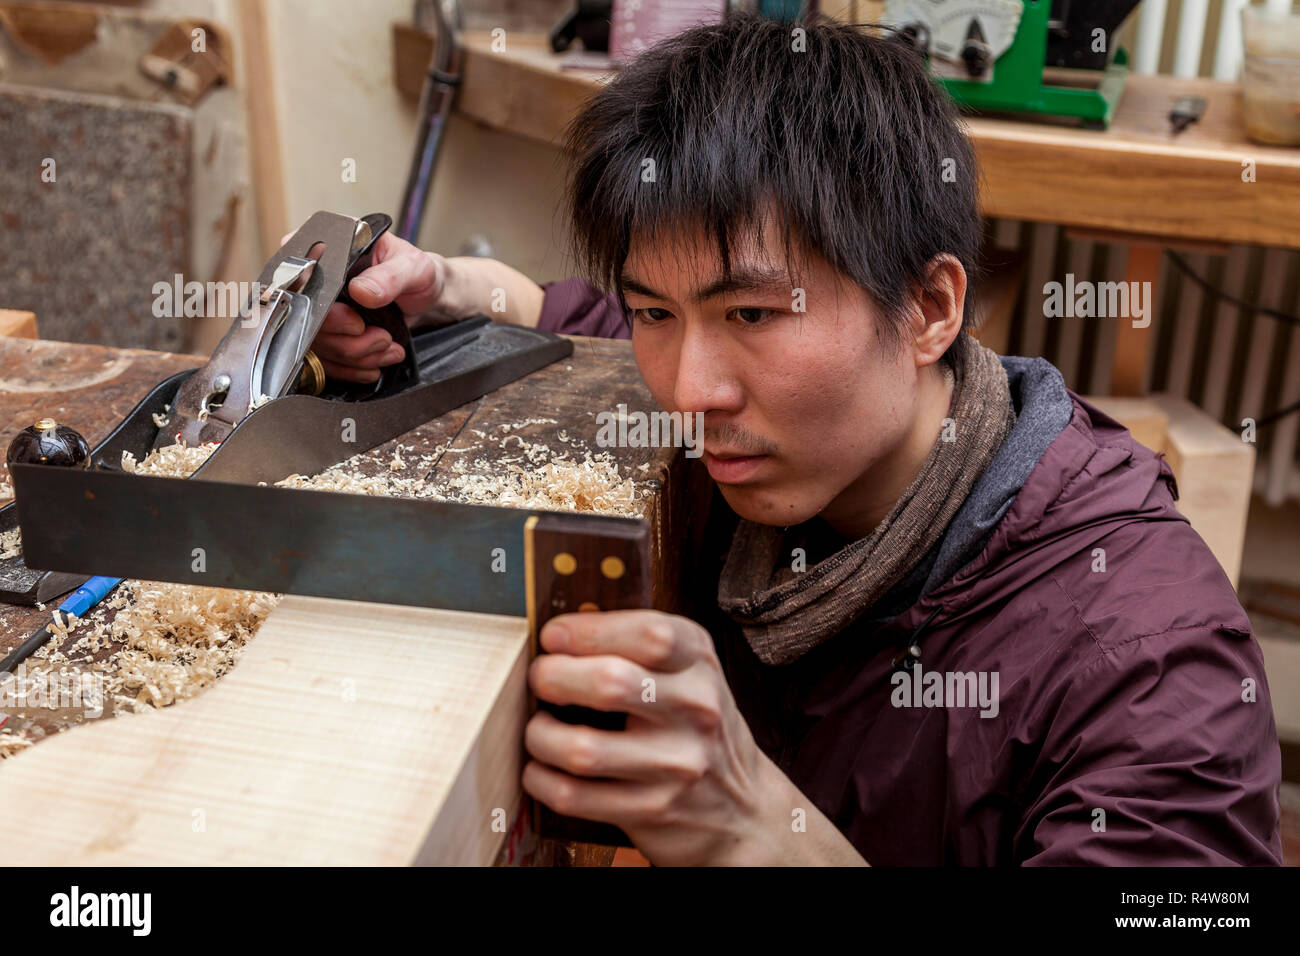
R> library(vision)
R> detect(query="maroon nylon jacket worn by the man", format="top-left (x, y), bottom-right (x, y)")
top-left (541, 280), bottom-right (1282, 865)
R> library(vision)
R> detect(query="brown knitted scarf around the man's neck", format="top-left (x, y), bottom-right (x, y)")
top-left (718, 334), bottom-right (1015, 665)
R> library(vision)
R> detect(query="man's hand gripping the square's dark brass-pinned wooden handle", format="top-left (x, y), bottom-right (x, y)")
top-left (524, 610), bottom-right (797, 865)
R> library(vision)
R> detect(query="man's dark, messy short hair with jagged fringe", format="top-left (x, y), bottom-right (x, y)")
top-left (566, 13), bottom-right (983, 358)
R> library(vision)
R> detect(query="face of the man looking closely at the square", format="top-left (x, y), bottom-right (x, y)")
top-left (623, 218), bottom-right (918, 533)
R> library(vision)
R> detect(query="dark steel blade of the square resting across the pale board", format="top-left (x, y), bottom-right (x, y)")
top-left (13, 464), bottom-right (644, 617)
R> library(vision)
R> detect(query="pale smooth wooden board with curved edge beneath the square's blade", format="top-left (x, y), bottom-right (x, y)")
top-left (0, 596), bottom-right (527, 865)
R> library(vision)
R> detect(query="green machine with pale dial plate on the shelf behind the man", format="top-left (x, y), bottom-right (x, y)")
top-left (881, 0), bottom-right (1139, 129)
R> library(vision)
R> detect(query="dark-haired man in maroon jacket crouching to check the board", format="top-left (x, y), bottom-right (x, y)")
top-left (319, 17), bottom-right (1281, 865)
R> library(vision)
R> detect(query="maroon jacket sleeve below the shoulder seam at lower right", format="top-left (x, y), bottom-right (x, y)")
top-left (1015, 626), bottom-right (1282, 866)
